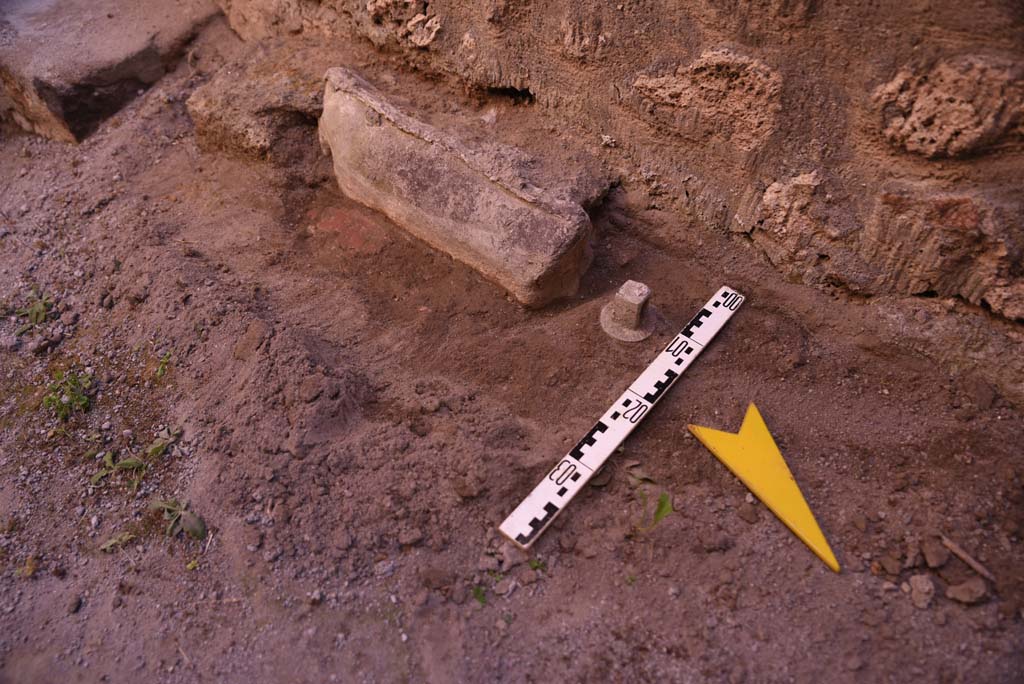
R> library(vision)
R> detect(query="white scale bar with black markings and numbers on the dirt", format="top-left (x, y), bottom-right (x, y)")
top-left (499, 288), bottom-right (743, 549)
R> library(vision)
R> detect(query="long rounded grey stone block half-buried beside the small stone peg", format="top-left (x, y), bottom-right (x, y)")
top-left (319, 68), bottom-right (592, 307)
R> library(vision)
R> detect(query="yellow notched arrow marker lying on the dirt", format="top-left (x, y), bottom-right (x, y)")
top-left (689, 403), bottom-right (839, 572)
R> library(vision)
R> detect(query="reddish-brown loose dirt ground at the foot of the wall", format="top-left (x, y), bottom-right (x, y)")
top-left (0, 15), bottom-right (1024, 683)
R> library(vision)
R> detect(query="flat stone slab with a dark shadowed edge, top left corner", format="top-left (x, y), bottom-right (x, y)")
top-left (0, 0), bottom-right (219, 142)
